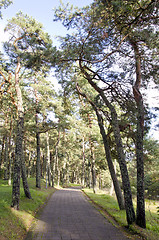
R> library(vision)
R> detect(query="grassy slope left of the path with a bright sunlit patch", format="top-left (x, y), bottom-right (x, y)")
top-left (0, 179), bottom-right (55, 240)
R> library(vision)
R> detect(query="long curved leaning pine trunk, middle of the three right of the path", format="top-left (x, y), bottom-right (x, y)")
top-left (79, 60), bottom-right (135, 225)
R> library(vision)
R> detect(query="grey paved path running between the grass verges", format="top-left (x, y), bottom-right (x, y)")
top-left (29, 188), bottom-right (131, 240)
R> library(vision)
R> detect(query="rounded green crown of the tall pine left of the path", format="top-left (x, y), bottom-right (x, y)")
top-left (4, 12), bottom-right (56, 71)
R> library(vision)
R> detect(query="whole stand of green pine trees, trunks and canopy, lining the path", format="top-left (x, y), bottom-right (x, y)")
top-left (0, 0), bottom-right (159, 234)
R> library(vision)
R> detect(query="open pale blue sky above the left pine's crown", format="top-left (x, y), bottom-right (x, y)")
top-left (0, 0), bottom-right (93, 45)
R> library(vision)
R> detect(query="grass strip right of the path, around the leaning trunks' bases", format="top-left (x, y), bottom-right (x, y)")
top-left (83, 189), bottom-right (159, 240)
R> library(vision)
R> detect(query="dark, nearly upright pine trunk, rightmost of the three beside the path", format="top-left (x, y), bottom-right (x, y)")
top-left (130, 39), bottom-right (146, 228)
